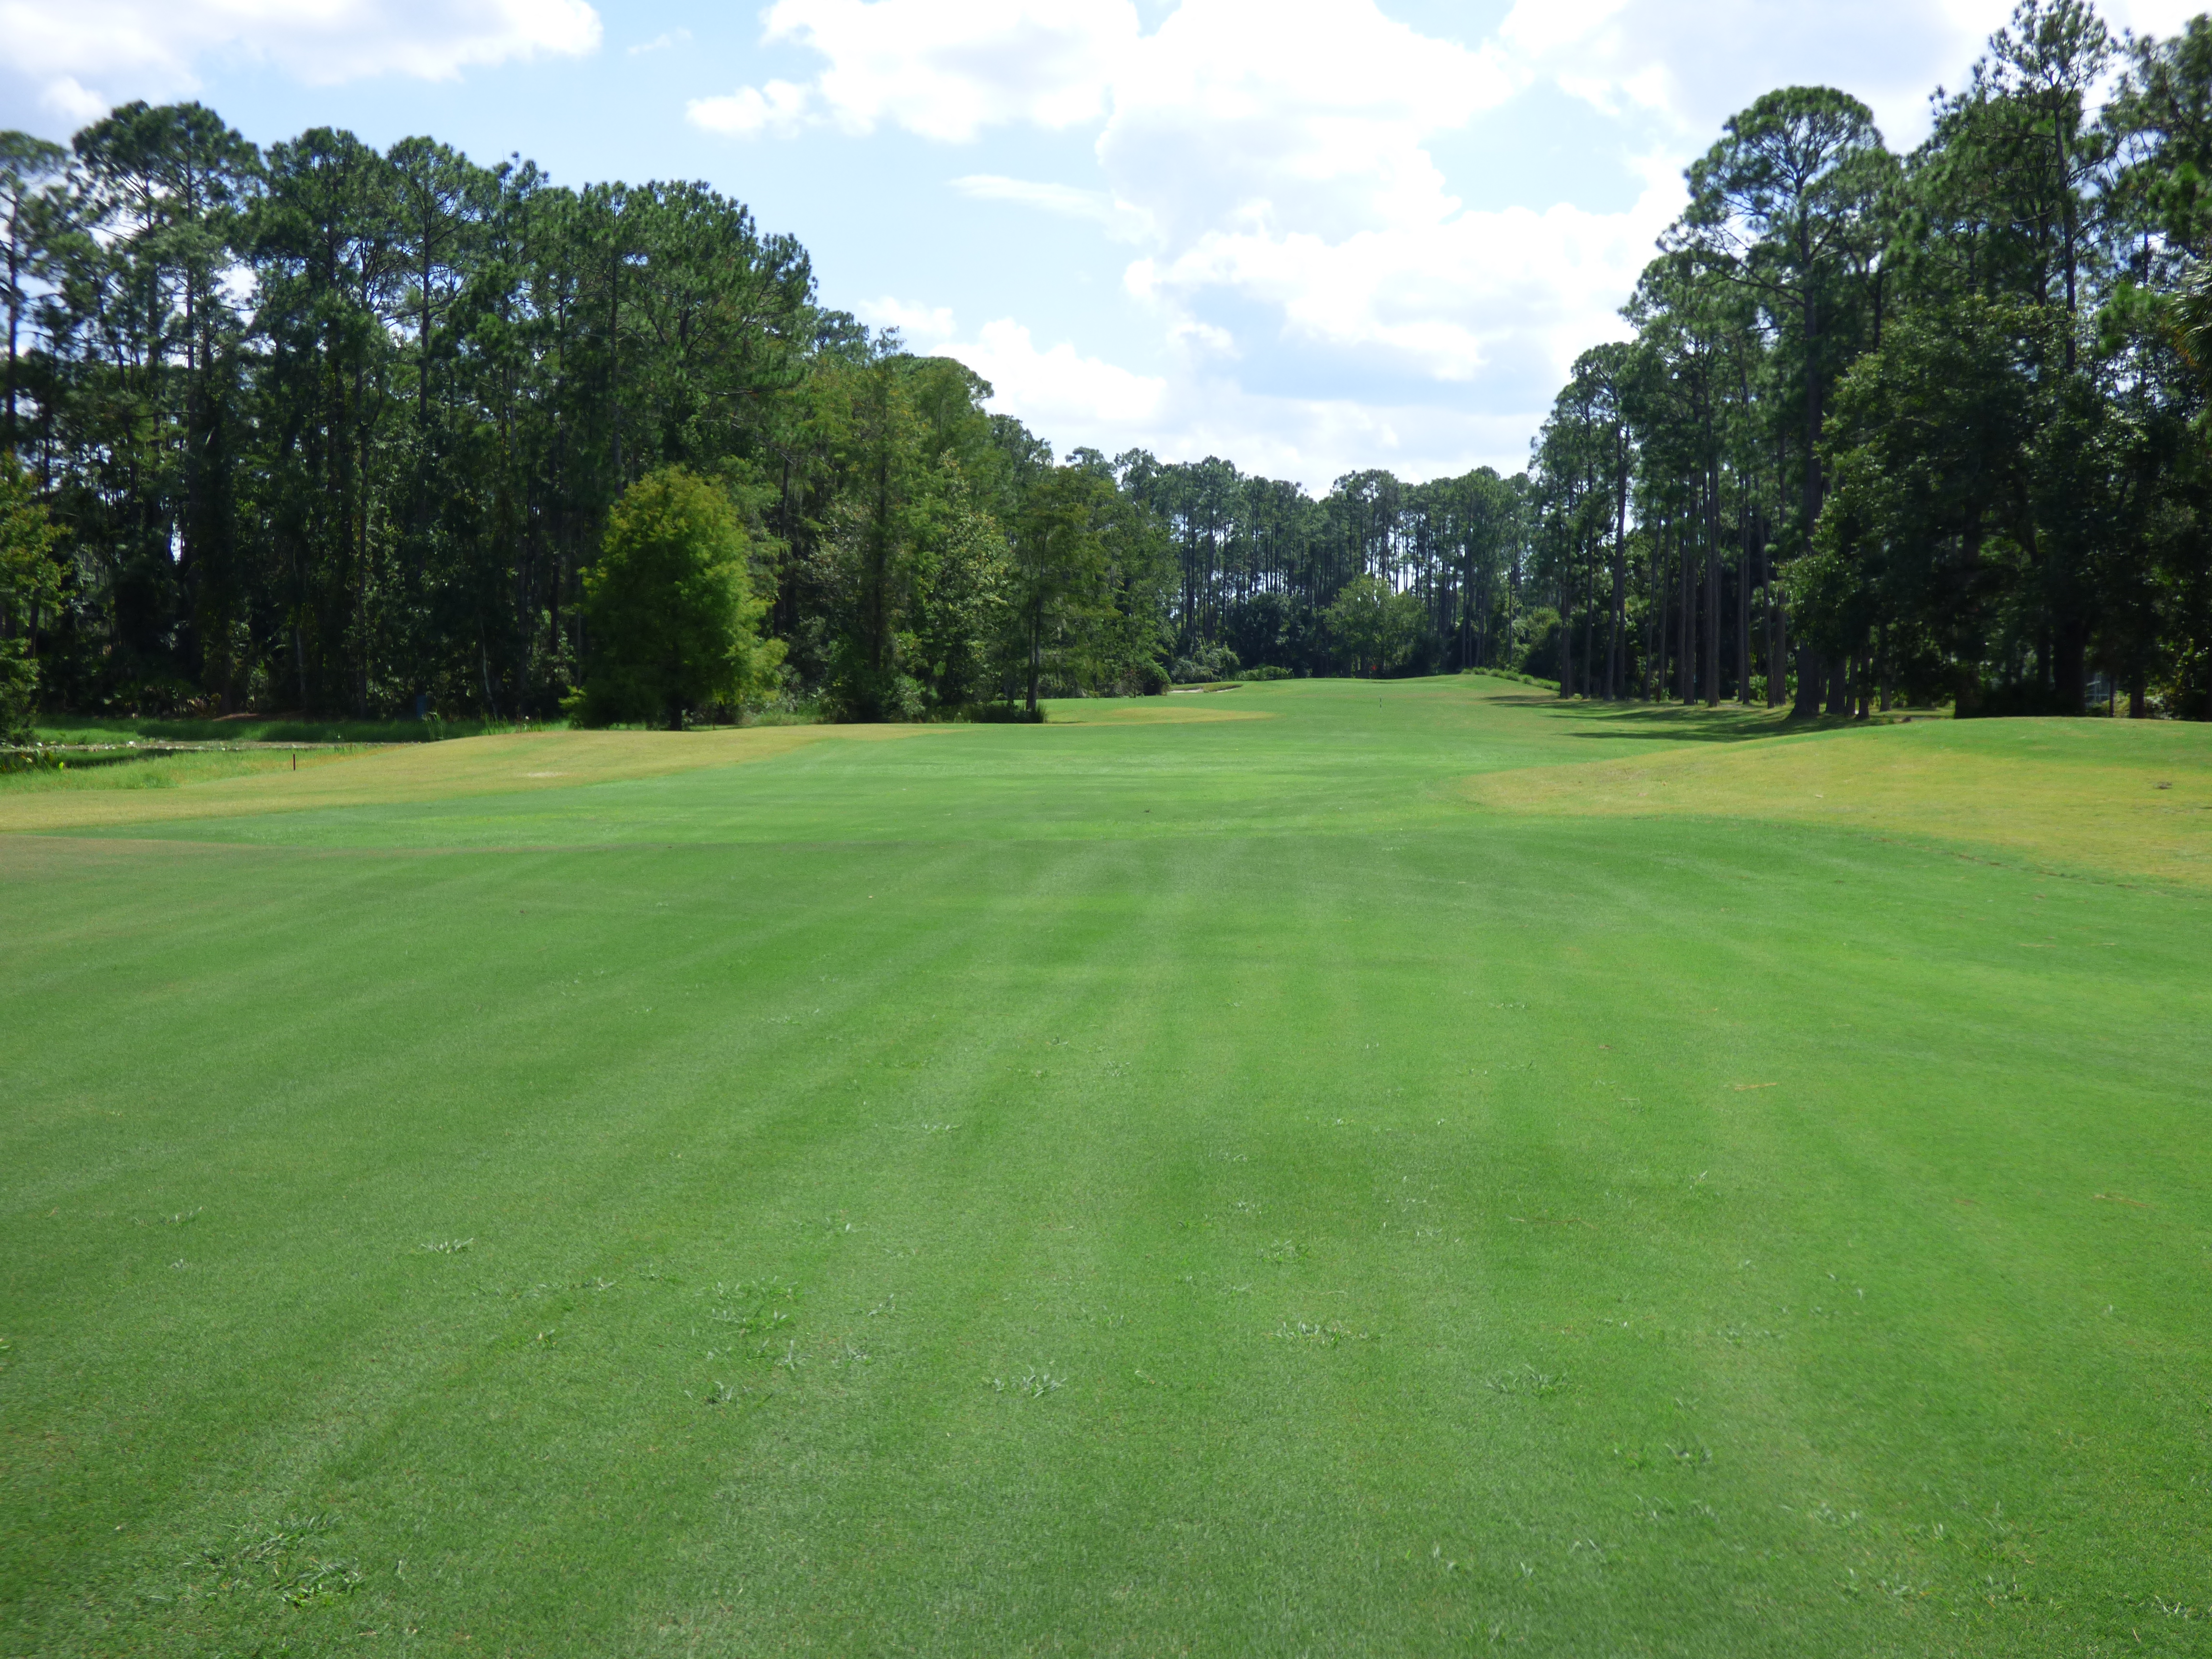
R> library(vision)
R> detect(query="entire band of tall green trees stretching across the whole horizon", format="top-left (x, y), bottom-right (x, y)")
top-left (0, 0), bottom-right (2212, 719)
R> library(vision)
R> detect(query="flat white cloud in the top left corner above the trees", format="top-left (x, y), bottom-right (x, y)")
top-left (0, 0), bottom-right (600, 120)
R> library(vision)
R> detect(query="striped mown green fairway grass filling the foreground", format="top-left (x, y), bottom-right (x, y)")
top-left (0, 681), bottom-right (2212, 1655)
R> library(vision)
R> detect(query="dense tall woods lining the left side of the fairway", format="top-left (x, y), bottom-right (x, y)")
top-left (0, 104), bottom-right (1170, 719)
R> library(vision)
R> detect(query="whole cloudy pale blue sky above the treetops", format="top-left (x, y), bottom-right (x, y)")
top-left (0, 0), bottom-right (2197, 491)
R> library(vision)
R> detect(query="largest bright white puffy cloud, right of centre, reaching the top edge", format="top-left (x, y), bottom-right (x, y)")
top-left (1097, 0), bottom-right (1654, 462)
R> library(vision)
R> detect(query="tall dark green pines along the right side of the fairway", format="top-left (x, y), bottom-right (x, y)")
top-left (1531, 0), bottom-right (2212, 719)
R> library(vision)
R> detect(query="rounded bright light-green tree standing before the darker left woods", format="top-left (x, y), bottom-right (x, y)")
top-left (564, 467), bottom-right (783, 730)
